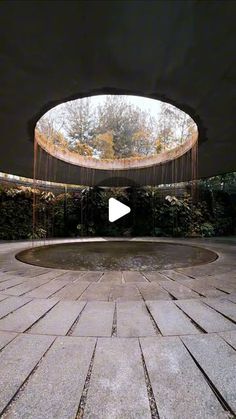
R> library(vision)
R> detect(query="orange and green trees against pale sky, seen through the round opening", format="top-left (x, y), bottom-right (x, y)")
top-left (37, 95), bottom-right (196, 160)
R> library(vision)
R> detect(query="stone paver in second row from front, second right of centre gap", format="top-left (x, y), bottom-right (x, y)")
top-left (147, 301), bottom-right (199, 336)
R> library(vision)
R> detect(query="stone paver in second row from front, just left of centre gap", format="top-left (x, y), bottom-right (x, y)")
top-left (72, 301), bottom-right (115, 337)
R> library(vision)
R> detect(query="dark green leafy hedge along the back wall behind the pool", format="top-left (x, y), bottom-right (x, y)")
top-left (0, 186), bottom-right (235, 240)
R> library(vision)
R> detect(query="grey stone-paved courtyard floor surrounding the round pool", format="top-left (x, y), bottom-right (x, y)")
top-left (0, 238), bottom-right (236, 419)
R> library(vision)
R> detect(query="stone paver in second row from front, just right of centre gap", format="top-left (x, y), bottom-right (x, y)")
top-left (116, 301), bottom-right (156, 337)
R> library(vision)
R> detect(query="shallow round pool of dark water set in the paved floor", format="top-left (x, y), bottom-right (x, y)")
top-left (16, 241), bottom-right (217, 271)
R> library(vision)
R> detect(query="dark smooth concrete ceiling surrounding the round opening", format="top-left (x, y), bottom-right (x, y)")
top-left (0, 0), bottom-right (236, 182)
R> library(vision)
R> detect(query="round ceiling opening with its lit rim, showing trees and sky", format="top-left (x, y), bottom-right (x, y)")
top-left (35, 95), bottom-right (198, 170)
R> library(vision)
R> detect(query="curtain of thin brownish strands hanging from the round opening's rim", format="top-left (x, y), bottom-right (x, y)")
top-left (32, 135), bottom-right (198, 243)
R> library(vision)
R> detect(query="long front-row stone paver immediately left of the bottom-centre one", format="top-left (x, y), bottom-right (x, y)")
top-left (3, 337), bottom-right (95, 419)
